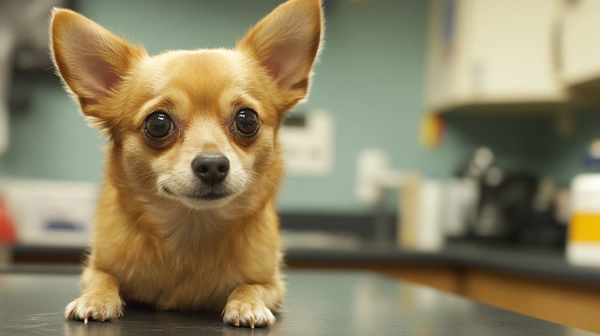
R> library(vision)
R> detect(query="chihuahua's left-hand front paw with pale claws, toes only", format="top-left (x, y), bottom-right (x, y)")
top-left (65, 293), bottom-right (123, 323)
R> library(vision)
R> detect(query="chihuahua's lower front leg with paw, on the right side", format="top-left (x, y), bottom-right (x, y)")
top-left (223, 280), bottom-right (285, 328)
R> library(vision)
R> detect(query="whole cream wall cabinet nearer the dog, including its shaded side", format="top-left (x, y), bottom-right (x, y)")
top-left (426, 0), bottom-right (568, 112)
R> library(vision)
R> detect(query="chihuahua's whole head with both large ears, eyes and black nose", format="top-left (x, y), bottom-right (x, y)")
top-left (51, 0), bottom-right (323, 209)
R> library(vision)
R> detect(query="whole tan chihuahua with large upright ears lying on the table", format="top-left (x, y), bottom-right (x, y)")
top-left (50, 0), bottom-right (323, 328)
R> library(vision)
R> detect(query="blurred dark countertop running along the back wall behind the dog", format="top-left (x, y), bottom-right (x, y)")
top-left (14, 242), bottom-right (600, 286)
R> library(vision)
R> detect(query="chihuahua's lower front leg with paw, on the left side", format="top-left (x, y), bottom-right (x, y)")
top-left (65, 266), bottom-right (123, 323)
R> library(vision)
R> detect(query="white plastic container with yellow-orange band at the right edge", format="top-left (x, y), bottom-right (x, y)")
top-left (567, 174), bottom-right (600, 266)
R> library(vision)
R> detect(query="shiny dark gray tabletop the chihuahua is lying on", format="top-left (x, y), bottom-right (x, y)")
top-left (0, 271), bottom-right (594, 336)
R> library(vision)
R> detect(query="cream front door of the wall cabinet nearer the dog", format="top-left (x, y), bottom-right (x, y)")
top-left (465, 0), bottom-right (561, 101)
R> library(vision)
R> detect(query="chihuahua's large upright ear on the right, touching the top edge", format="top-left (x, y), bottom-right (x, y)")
top-left (237, 0), bottom-right (323, 111)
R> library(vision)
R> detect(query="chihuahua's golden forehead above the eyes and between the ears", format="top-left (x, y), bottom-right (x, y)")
top-left (124, 49), bottom-right (274, 120)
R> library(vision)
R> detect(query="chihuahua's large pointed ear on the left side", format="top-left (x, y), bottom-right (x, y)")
top-left (50, 8), bottom-right (147, 120)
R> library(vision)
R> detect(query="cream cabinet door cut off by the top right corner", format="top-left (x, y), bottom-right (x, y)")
top-left (561, 0), bottom-right (600, 92)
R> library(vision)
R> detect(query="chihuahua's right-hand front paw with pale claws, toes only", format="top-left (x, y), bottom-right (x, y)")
top-left (223, 300), bottom-right (275, 329)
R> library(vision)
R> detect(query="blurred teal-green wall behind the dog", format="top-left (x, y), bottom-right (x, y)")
top-left (0, 0), bottom-right (580, 212)
